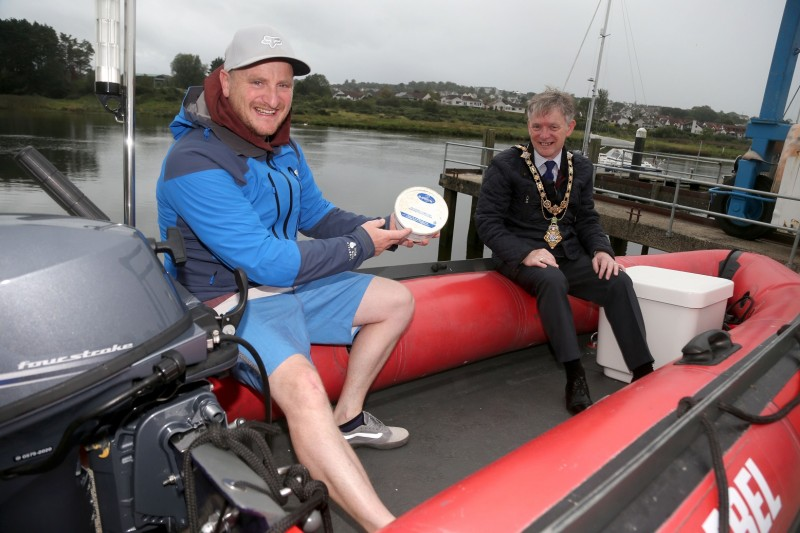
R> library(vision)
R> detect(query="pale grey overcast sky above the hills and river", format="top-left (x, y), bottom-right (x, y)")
top-left (0, 0), bottom-right (800, 120)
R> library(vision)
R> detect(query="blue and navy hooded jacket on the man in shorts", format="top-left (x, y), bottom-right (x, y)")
top-left (156, 87), bottom-right (375, 301)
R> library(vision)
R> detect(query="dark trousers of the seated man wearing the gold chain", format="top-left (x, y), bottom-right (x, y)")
top-left (498, 255), bottom-right (653, 369)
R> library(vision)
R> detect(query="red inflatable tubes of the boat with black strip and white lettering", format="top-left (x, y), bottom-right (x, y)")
top-left (215, 250), bottom-right (800, 532)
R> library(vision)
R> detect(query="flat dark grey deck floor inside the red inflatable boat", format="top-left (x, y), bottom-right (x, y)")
top-left (272, 336), bottom-right (625, 533)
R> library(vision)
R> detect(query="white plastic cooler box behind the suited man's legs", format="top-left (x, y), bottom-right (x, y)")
top-left (597, 266), bottom-right (733, 383)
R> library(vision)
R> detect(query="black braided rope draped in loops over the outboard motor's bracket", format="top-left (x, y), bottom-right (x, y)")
top-left (183, 422), bottom-right (333, 532)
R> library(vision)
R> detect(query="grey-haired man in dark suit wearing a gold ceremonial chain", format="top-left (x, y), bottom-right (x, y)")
top-left (475, 88), bottom-right (653, 414)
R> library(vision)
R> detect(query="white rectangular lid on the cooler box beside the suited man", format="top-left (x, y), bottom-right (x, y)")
top-left (625, 265), bottom-right (733, 309)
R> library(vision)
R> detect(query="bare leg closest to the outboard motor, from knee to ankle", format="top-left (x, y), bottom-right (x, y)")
top-left (269, 355), bottom-right (394, 531)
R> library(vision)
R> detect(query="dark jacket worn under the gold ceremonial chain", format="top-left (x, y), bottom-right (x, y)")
top-left (475, 145), bottom-right (614, 266)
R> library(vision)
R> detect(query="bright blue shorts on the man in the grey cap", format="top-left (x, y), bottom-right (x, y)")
top-left (227, 272), bottom-right (373, 390)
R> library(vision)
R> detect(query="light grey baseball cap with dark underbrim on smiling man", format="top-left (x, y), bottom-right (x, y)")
top-left (225, 26), bottom-right (311, 76)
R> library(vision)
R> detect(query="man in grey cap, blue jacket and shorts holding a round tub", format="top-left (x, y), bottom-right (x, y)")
top-left (156, 26), bottom-right (427, 530)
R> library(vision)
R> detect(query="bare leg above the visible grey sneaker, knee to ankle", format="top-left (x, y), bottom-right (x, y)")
top-left (334, 277), bottom-right (414, 424)
